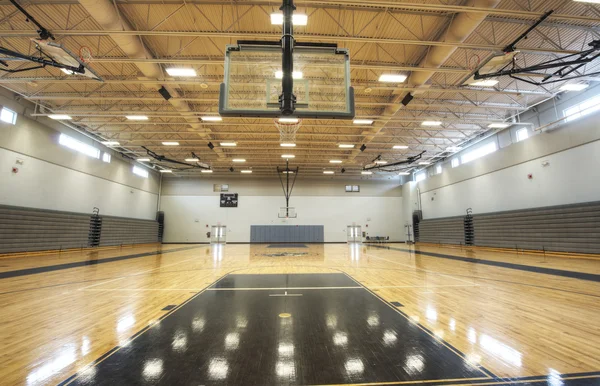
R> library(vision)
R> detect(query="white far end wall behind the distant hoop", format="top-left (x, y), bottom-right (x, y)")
top-left (161, 178), bottom-right (404, 242)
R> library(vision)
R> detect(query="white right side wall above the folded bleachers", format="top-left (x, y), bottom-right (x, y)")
top-left (418, 114), bottom-right (600, 218)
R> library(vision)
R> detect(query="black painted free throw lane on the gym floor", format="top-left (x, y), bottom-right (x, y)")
top-left (67, 274), bottom-right (487, 386)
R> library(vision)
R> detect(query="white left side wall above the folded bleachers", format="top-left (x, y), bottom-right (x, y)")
top-left (0, 89), bottom-right (159, 219)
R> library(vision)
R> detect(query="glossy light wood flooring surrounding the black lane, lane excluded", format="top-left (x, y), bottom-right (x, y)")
top-left (0, 244), bottom-right (600, 385)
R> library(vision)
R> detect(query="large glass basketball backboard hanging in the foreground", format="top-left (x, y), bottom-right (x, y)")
top-left (219, 42), bottom-right (354, 119)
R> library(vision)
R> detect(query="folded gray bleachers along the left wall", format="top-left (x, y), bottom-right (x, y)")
top-left (0, 205), bottom-right (158, 253)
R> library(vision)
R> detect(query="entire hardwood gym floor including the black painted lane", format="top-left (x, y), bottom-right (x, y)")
top-left (0, 244), bottom-right (600, 385)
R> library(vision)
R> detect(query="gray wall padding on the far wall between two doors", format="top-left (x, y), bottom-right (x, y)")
top-left (250, 225), bottom-right (325, 243)
